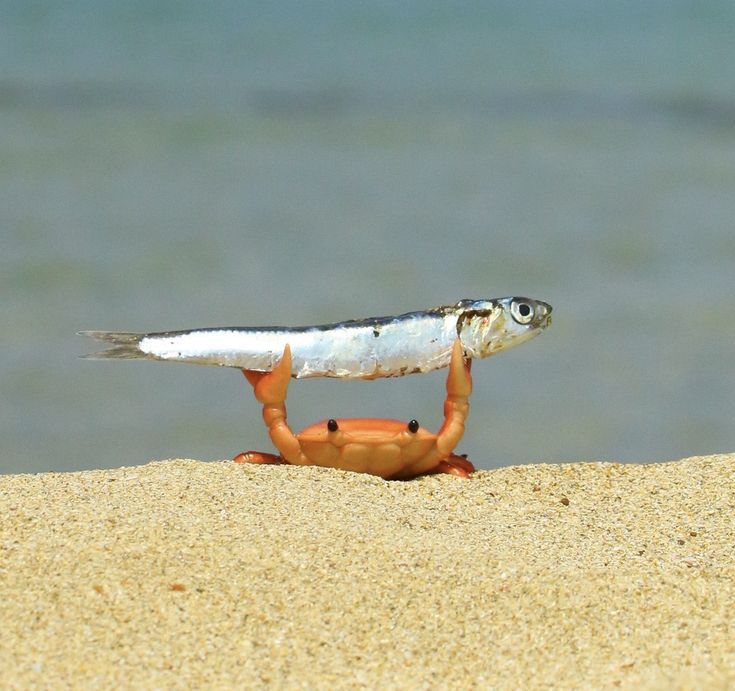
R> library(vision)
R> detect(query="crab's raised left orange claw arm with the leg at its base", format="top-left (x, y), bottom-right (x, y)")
top-left (237, 343), bottom-right (309, 465)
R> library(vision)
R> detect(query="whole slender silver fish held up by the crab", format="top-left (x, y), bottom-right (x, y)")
top-left (79, 297), bottom-right (551, 379)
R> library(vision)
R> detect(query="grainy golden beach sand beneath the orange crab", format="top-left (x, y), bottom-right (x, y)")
top-left (0, 454), bottom-right (735, 689)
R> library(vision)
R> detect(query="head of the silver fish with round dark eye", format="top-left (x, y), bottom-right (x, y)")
top-left (456, 297), bottom-right (551, 358)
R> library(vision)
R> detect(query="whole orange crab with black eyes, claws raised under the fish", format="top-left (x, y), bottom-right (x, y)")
top-left (233, 339), bottom-right (475, 480)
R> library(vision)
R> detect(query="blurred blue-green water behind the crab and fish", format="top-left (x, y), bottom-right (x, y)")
top-left (0, 0), bottom-right (735, 472)
